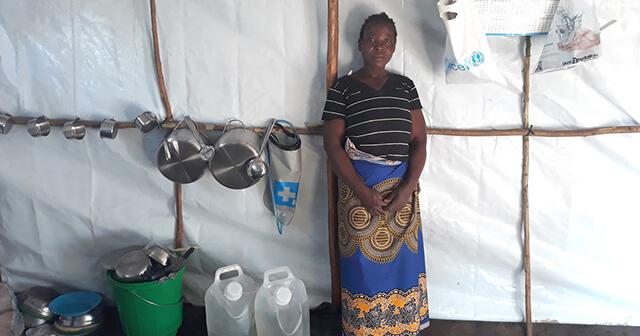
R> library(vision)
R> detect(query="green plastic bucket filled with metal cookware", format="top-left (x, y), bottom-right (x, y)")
top-left (107, 267), bottom-right (185, 336)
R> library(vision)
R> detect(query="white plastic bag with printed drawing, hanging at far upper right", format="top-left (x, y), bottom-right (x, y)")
top-left (535, 0), bottom-right (600, 73)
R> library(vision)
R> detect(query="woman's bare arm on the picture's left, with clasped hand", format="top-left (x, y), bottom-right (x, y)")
top-left (323, 119), bottom-right (388, 214)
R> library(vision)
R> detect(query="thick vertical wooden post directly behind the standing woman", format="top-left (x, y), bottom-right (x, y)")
top-left (326, 0), bottom-right (341, 304)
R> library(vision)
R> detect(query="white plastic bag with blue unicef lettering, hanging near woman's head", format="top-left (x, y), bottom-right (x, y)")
top-left (438, 0), bottom-right (505, 85)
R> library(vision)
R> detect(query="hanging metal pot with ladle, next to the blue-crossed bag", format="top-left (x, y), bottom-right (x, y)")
top-left (209, 119), bottom-right (274, 189)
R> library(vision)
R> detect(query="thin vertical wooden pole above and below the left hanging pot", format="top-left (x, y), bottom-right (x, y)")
top-left (149, 0), bottom-right (184, 248)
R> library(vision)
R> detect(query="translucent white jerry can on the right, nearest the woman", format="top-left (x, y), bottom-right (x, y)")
top-left (255, 266), bottom-right (311, 336)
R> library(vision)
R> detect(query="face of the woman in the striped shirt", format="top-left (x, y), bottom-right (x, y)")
top-left (358, 22), bottom-right (396, 68)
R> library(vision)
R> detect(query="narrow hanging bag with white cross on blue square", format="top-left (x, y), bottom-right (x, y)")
top-left (269, 120), bottom-right (302, 234)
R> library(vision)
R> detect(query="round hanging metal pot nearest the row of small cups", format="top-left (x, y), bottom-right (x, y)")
top-left (156, 116), bottom-right (214, 184)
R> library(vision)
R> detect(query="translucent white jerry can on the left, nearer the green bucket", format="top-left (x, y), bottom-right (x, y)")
top-left (204, 265), bottom-right (258, 336)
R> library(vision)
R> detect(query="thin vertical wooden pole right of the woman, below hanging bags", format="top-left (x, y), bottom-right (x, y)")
top-left (522, 36), bottom-right (533, 336)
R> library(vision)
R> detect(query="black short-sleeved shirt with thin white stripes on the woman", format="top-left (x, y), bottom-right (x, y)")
top-left (322, 73), bottom-right (422, 161)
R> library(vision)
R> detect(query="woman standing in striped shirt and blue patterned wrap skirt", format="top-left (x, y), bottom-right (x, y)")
top-left (322, 13), bottom-right (429, 336)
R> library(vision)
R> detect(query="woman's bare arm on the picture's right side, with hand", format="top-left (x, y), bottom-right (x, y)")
top-left (384, 109), bottom-right (427, 212)
